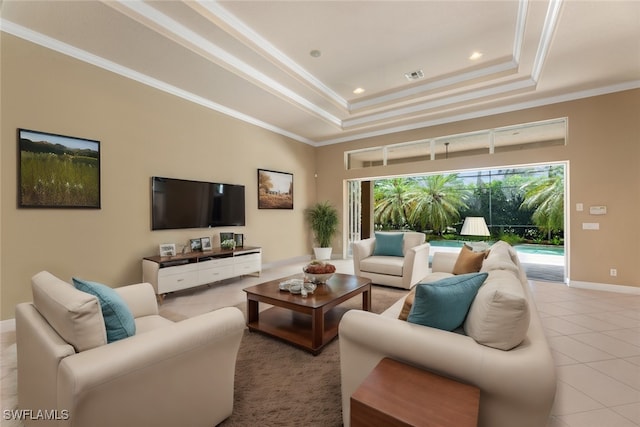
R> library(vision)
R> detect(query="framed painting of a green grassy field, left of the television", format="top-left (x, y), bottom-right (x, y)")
top-left (18, 129), bottom-right (100, 209)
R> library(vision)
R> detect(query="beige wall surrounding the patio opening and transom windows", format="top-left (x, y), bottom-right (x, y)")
top-left (317, 90), bottom-right (640, 287)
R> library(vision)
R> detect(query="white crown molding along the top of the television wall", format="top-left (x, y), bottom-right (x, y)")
top-left (0, 18), bottom-right (315, 145)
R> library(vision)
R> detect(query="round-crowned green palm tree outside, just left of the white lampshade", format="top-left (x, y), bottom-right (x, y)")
top-left (407, 174), bottom-right (468, 234)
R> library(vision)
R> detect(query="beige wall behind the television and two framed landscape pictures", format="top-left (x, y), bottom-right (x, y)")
top-left (0, 33), bottom-right (316, 319)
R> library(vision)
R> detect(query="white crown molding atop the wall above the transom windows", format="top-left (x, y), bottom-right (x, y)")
top-left (314, 80), bottom-right (640, 147)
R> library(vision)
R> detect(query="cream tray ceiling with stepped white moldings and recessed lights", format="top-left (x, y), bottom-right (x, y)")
top-left (1, 0), bottom-right (640, 146)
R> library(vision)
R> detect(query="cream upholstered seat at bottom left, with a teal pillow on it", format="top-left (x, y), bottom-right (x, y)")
top-left (16, 271), bottom-right (245, 427)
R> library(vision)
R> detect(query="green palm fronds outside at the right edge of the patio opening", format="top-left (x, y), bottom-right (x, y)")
top-left (521, 166), bottom-right (564, 237)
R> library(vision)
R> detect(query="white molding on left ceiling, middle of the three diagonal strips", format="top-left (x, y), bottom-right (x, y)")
top-left (105, 0), bottom-right (341, 128)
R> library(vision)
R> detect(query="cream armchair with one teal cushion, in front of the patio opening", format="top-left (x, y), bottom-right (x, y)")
top-left (352, 232), bottom-right (429, 289)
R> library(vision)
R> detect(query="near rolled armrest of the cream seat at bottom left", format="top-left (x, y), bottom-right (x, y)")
top-left (58, 307), bottom-right (245, 427)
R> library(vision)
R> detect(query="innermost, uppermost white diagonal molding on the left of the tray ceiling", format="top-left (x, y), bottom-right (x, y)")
top-left (185, 0), bottom-right (349, 110)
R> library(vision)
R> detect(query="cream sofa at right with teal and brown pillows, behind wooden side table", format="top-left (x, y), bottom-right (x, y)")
top-left (339, 242), bottom-right (556, 427)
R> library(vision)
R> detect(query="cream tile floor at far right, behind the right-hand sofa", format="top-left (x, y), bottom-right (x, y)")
top-left (531, 281), bottom-right (640, 427)
